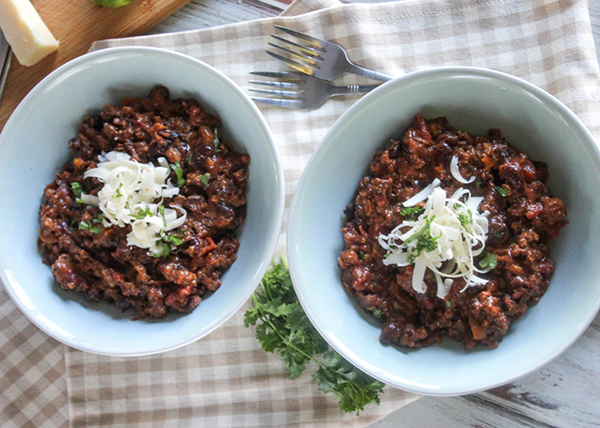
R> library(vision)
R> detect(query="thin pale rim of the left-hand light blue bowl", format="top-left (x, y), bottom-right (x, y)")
top-left (0, 46), bottom-right (285, 357)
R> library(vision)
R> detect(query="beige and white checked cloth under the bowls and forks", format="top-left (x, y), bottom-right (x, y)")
top-left (0, 0), bottom-right (600, 427)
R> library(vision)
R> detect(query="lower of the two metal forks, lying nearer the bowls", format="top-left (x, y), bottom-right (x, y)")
top-left (248, 71), bottom-right (379, 110)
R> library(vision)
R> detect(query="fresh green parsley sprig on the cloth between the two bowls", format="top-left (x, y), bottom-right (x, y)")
top-left (244, 256), bottom-right (384, 414)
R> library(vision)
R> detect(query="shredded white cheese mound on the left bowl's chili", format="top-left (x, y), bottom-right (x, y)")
top-left (81, 151), bottom-right (187, 255)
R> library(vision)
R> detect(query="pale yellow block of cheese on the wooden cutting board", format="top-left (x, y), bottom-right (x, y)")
top-left (0, 0), bottom-right (58, 66)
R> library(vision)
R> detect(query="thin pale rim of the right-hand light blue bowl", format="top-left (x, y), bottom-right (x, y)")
top-left (286, 66), bottom-right (600, 397)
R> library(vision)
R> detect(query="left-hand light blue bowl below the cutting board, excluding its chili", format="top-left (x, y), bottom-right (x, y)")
top-left (0, 48), bottom-right (284, 356)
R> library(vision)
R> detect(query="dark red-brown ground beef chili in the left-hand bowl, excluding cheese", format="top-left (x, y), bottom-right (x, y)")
top-left (38, 86), bottom-right (250, 318)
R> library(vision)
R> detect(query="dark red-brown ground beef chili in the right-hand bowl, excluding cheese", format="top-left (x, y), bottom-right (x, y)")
top-left (338, 115), bottom-right (567, 348)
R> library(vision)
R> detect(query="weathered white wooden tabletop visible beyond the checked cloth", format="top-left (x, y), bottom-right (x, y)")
top-left (152, 0), bottom-right (600, 428)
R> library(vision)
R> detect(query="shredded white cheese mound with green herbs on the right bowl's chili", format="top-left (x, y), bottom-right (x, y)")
top-left (378, 186), bottom-right (489, 299)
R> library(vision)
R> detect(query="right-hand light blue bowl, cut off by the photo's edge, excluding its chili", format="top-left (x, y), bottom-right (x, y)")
top-left (288, 67), bottom-right (600, 395)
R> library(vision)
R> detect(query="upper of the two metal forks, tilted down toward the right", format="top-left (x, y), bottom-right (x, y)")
top-left (267, 25), bottom-right (392, 82)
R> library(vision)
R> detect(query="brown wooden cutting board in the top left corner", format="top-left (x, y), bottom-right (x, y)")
top-left (0, 0), bottom-right (190, 130)
